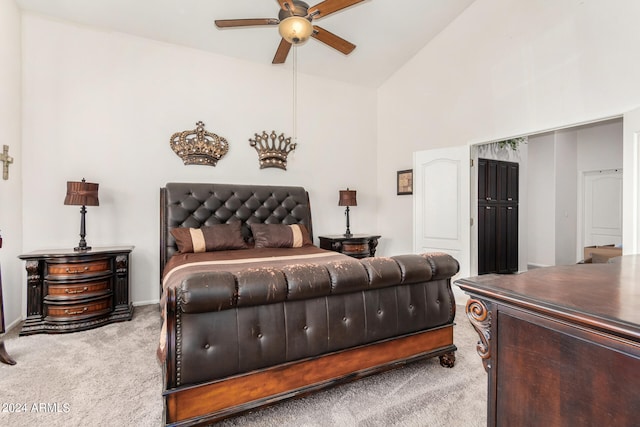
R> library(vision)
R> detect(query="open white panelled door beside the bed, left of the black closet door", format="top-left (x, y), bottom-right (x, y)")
top-left (413, 146), bottom-right (471, 277)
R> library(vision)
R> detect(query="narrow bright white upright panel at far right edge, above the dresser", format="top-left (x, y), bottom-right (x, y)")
top-left (622, 108), bottom-right (640, 255)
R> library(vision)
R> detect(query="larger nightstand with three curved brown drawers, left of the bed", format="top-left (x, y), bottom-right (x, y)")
top-left (19, 246), bottom-right (133, 335)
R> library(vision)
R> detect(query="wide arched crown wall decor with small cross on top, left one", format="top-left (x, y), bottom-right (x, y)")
top-left (169, 121), bottom-right (229, 166)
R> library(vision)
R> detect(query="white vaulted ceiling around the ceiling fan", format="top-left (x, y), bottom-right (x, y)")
top-left (16, 0), bottom-right (474, 87)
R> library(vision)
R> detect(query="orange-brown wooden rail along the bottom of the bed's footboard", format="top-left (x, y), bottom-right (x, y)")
top-left (164, 324), bottom-right (457, 426)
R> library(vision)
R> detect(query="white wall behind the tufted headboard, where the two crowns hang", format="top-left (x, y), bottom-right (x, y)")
top-left (23, 15), bottom-right (378, 303)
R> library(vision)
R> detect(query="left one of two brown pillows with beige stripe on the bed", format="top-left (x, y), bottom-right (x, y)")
top-left (171, 222), bottom-right (247, 254)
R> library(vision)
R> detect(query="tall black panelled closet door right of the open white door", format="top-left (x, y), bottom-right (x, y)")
top-left (478, 159), bottom-right (519, 274)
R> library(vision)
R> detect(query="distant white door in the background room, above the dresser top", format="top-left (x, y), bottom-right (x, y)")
top-left (582, 169), bottom-right (622, 246)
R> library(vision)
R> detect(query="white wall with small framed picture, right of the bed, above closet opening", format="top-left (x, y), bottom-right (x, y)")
top-left (378, 0), bottom-right (640, 262)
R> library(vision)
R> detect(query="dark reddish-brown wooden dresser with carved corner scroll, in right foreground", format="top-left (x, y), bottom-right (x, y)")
top-left (456, 255), bottom-right (640, 427)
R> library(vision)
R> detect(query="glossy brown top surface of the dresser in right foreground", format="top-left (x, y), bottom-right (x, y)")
top-left (455, 255), bottom-right (640, 339)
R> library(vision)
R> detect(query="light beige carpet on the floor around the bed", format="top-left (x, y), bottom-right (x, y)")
top-left (0, 305), bottom-right (487, 427)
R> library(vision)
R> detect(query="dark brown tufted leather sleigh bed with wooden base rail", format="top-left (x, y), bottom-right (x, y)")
top-left (158, 183), bottom-right (458, 425)
